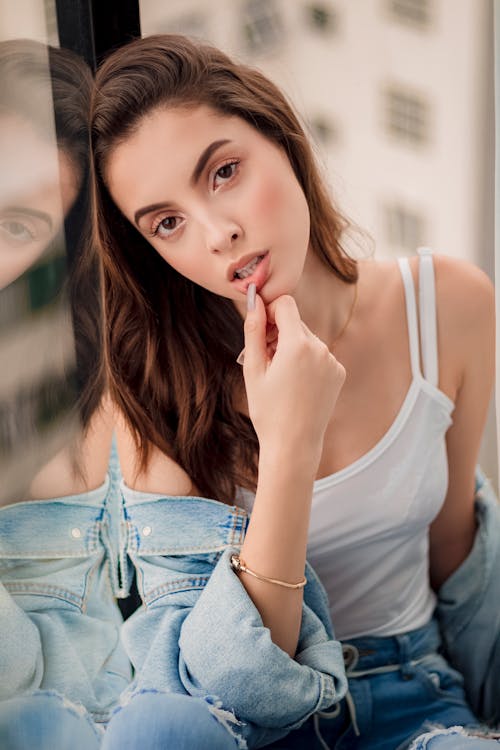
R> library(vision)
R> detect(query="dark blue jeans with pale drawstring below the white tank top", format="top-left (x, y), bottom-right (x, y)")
top-left (268, 621), bottom-right (500, 750)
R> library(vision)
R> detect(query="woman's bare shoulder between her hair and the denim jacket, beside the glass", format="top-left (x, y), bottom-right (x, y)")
top-left (115, 413), bottom-right (198, 496)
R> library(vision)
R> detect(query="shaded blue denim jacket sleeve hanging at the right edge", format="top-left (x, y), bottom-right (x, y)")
top-left (436, 469), bottom-right (500, 725)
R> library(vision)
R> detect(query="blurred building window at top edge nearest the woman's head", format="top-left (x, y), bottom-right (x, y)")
top-left (243, 0), bottom-right (284, 54)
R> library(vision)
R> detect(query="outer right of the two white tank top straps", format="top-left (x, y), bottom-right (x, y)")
top-left (417, 247), bottom-right (438, 388)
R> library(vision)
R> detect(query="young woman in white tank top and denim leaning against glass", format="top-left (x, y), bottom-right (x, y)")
top-left (91, 36), bottom-right (498, 750)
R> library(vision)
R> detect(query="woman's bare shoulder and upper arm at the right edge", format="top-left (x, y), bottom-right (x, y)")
top-left (430, 256), bottom-right (495, 589)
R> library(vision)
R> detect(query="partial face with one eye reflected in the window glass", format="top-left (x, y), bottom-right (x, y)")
top-left (0, 117), bottom-right (78, 289)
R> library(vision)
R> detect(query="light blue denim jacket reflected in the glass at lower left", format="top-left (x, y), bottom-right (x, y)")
top-left (0, 478), bottom-right (131, 722)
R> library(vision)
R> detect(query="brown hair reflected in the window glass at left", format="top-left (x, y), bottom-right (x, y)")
top-left (0, 39), bottom-right (104, 438)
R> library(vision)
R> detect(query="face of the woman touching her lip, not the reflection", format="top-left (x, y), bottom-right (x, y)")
top-left (105, 106), bottom-right (309, 305)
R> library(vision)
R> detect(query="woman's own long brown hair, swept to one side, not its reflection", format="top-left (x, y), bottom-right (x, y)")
top-left (91, 36), bottom-right (357, 502)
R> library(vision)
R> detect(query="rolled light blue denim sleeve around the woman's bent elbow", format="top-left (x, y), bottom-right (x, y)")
top-left (179, 550), bottom-right (347, 728)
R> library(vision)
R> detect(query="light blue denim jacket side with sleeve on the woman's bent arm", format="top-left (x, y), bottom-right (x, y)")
top-left (118, 486), bottom-right (347, 748)
